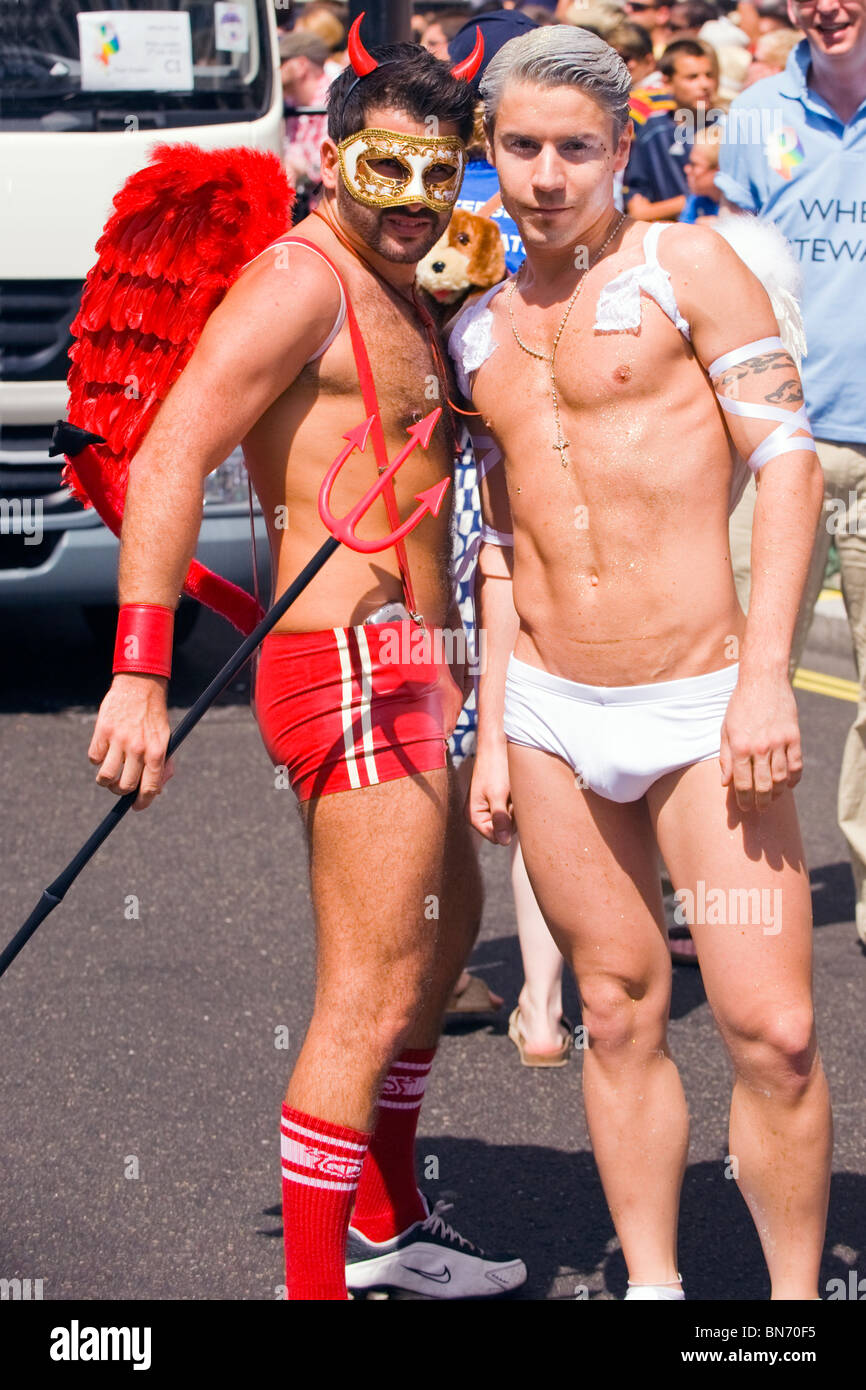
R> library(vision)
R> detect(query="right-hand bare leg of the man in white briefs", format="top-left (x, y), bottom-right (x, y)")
top-left (646, 759), bottom-right (833, 1298)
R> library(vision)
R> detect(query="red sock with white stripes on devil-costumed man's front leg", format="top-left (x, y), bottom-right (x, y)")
top-left (279, 1102), bottom-right (370, 1300)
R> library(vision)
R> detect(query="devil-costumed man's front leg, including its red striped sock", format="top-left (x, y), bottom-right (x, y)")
top-left (281, 769), bottom-right (448, 1300)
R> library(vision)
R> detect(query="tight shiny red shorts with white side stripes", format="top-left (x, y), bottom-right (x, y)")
top-left (254, 621), bottom-right (452, 801)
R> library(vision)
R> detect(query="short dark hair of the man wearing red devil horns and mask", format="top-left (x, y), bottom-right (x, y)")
top-left (328, 43), bottom-right (475, 145)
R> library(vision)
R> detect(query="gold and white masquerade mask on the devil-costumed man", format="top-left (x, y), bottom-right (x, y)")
top-left (336, 129), bottom-right (466, 213)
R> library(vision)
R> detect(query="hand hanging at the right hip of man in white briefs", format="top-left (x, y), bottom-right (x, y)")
top-left (719, 674), bottom-right (803, 810)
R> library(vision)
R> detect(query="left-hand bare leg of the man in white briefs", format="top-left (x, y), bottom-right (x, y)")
top-left (509, 744), bottom-right (688, 1284)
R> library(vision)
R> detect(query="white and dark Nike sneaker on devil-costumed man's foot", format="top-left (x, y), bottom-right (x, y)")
top-left (346, 1200), bottom-right (527, 1298)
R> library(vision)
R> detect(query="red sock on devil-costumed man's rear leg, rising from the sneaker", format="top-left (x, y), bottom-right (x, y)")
top-left (352, 1048), bottom-right (435, 1240)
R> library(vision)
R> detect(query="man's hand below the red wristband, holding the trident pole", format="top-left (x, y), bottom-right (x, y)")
top-left (88, 673), bottom-right (174, 810)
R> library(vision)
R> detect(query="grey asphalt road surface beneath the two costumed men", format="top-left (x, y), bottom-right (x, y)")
top-left (0, 610), bottom-right (866, 1300)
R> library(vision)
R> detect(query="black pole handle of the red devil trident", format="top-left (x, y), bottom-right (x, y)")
top-left (0, 535), bottom-right (341, 976)
